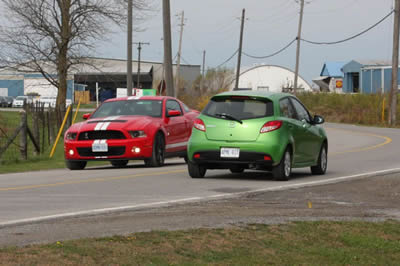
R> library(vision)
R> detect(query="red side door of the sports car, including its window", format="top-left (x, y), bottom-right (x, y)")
top-left (165, 99), bottom-right (188, 152)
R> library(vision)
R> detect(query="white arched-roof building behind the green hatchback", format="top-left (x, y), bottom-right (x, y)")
top-left (231, 65), bottom-right (312, 92)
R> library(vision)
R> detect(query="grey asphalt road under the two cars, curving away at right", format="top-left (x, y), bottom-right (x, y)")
top-left (0, 124), bottom-right (400, 227)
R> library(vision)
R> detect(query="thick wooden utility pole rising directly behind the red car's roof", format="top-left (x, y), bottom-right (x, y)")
top-left (163, 0), bottom-right (175, 96)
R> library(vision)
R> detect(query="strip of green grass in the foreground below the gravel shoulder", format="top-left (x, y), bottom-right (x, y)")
top-left (0, 221), bottom-right (400, 265)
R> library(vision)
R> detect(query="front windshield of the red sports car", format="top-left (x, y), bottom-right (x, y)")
top-left (90, 100), bottom-right (162, 118)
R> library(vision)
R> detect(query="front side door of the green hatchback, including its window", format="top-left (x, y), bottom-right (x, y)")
top-left (290, 97), bottom-right (320, 163)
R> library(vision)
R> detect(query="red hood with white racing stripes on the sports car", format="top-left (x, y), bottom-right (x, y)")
top-left (68, 116), bottom-right (161, 132)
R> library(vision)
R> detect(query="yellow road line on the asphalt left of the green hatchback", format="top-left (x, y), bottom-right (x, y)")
top-left (0, 170), bottom-right (186, 191)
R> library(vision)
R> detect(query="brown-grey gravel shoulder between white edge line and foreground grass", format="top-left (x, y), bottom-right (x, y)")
top-left (0, 174), bottom-right (400, 247)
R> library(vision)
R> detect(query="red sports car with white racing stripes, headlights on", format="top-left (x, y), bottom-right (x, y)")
top-left (64, 96), bottom-right (199, 170)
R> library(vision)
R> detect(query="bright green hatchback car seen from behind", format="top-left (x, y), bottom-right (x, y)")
top-left (187, 91), bottom-right (328, 180)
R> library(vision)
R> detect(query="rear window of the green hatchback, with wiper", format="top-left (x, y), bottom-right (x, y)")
top-left (202, 96), bottom-right (274, 121)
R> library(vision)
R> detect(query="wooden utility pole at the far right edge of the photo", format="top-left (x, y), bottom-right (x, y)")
top-left (389, 0), bottom-right (400, 126)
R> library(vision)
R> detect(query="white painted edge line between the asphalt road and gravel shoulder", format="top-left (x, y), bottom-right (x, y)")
top-left (0, 168), bottom-right (400, 228)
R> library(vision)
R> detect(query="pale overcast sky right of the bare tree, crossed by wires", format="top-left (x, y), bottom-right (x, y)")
top-left (97, 0), bottom-right (393, 81)
